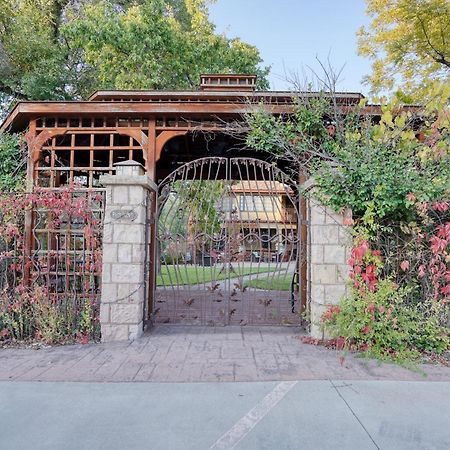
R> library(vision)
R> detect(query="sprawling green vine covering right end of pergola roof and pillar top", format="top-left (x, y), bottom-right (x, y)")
top-left (247, 93), bottom-right (450, 237)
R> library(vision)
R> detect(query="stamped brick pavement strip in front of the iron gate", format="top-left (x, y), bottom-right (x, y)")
top-left (0, 325), bottom-right (450, 382)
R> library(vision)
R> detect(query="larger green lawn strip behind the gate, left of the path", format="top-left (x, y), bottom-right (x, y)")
top-left (156, 266), bottom-right (275, 286)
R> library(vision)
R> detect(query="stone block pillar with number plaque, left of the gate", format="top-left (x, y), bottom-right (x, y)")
top-left (100, 161), bottom-right (154, 342)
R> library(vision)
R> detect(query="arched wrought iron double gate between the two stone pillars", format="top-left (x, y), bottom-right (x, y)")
top-left (151, 157), bottom-right (305, 325)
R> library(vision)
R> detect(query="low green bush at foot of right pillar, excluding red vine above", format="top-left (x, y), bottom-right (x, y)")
top-left (322, 280), bottom-right (450, 361)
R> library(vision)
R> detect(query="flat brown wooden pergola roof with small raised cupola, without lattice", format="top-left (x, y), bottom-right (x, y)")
top-left (0, 74), bottom-right (372, 132)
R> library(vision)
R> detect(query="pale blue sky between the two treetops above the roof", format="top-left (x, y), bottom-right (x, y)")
top-left (210, 0), bottom-right (370, 94)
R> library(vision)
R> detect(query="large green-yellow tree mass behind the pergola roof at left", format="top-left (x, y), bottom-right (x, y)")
top-left (0, 0), bottom-right (268, 111)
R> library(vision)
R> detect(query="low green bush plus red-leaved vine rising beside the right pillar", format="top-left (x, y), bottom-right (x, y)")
top-left (322, 241), bottom-right (450, 362)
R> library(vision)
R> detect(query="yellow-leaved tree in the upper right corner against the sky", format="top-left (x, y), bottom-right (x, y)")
top-left (358, 0), bottom-right (450, 100)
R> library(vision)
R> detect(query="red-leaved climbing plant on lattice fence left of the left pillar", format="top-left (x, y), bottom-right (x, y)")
top-left (0, 187), bottom-right (104, 343)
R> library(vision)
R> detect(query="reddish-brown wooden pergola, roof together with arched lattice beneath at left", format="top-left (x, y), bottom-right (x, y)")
top-left (0, 75), bottom-right (372, 189)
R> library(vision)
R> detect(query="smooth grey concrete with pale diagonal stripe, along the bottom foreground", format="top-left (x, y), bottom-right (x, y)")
top-left (0, 380), bottom-right (450, 450)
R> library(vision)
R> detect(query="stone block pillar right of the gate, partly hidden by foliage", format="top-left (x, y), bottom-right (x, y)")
top-left (307, 195), bottom-right (352, 339)
